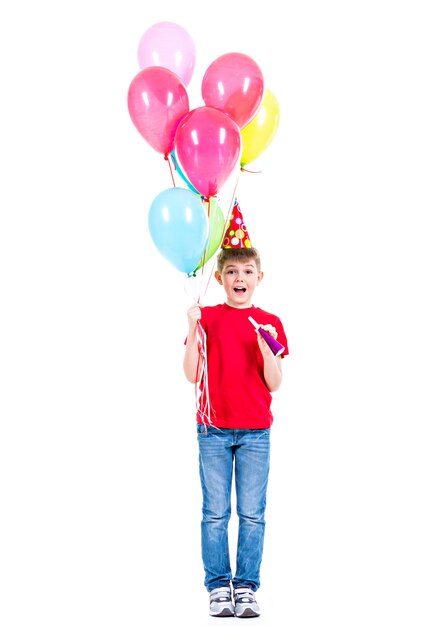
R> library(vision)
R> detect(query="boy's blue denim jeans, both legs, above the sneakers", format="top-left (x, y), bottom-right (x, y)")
top-left (197, 424), bottom-right (270, 591)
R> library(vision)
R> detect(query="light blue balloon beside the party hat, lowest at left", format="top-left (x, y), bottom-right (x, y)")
top-left (149, 187), bottom-right (209, 274)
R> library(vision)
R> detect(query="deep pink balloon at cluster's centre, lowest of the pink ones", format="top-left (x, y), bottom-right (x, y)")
top-left (175, 106), bottom-right (241, 197)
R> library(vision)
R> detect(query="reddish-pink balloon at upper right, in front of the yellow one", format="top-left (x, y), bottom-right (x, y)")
top-left (201, 52), bottom-right (264, 128)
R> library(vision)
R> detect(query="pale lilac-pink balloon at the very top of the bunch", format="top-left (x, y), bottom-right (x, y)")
top-left (137, 22), bottom-right (195, 85)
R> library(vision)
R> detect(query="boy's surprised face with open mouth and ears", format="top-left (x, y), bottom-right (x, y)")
top-left (215, 259), bottom-right (264, 309)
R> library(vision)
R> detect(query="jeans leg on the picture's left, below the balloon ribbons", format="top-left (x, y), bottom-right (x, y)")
top-left (197, 425), bottom-right (233, 591)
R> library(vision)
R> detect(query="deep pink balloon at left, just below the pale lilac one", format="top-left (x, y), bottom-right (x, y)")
top-left (128, 67), bottom-right (189, 156)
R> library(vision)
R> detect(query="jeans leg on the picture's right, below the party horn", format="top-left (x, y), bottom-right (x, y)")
top-left (232, 428), bottom-right (270, 591)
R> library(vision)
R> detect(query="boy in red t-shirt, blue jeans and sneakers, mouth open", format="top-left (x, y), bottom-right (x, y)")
top-left (183, 207), bottom-right (288, 617)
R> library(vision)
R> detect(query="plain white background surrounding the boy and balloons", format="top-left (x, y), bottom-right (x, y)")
top-left (0, 0), bottom-right (429, 626)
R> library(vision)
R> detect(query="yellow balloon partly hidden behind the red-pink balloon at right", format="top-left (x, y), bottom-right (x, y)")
top-left (240, 89), bottom-right (280, 166)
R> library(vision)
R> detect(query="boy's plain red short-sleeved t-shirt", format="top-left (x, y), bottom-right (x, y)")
top-left (197, 304), bottom-right (289, 428)
